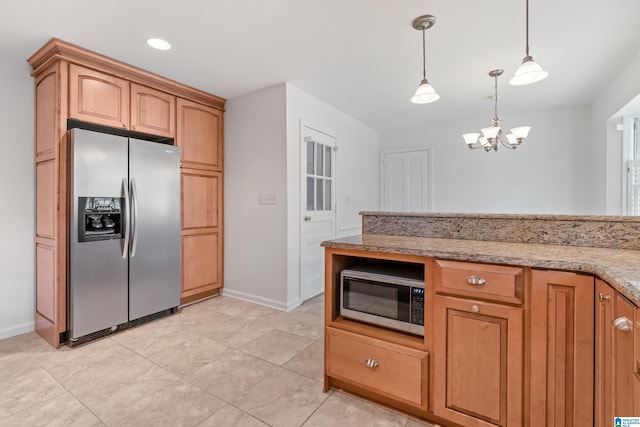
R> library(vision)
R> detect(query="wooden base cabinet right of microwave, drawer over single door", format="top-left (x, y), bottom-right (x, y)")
top-left (432, 260), bottom-right (524, 427)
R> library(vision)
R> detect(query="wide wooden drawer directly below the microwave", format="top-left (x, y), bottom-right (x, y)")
top-left (326, 328), bottom-right (429, 408)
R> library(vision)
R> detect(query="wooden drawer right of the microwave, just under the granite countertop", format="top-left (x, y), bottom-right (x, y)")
top-left (435, 260), bottom-right (524, 304)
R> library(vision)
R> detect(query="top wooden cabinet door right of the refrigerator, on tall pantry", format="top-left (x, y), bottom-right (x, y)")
top-left (176, 98), bottom-right (223, 171)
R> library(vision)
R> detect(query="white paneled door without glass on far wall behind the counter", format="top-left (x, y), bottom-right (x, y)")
top-left (382, 148), bottom-right (431, 212)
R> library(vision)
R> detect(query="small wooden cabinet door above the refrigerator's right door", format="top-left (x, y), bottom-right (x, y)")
top-left (131, 83), bottom-right (176, 138)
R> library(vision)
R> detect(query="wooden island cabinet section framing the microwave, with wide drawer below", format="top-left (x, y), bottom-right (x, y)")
top-left (324, 250), bottom-right (429, 415)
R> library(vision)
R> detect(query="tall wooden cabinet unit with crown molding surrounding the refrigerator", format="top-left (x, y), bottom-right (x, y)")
top-left (28, 38), bottom-right (225, 347)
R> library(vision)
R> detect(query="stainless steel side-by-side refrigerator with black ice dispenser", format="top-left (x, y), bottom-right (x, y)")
top-left (69, 129), bottom-right (181, 342)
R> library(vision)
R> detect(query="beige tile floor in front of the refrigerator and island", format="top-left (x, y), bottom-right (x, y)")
top-left (0, 296), bottom-right (436, 427)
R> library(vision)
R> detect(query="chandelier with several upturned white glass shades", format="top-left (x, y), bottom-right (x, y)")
top-left (462, 69), bottom-right (531, 152)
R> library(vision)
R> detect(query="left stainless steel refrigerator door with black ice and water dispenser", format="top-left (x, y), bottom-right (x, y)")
top-left (69, 129), bottom-right (128, 339)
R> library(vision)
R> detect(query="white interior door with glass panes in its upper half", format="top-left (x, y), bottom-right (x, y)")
top-left (300, 125), bottom-right (336, 301)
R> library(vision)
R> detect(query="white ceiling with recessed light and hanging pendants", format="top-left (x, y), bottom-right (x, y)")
top-left (5, 0), bottom-right (640, 130)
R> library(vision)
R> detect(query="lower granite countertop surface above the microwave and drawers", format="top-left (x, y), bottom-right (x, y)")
top-left (322, 234), bottom-right (640, 306)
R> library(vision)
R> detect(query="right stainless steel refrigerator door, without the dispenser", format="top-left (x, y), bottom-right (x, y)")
top-left (129, 139), bottom-right (181, 320)
